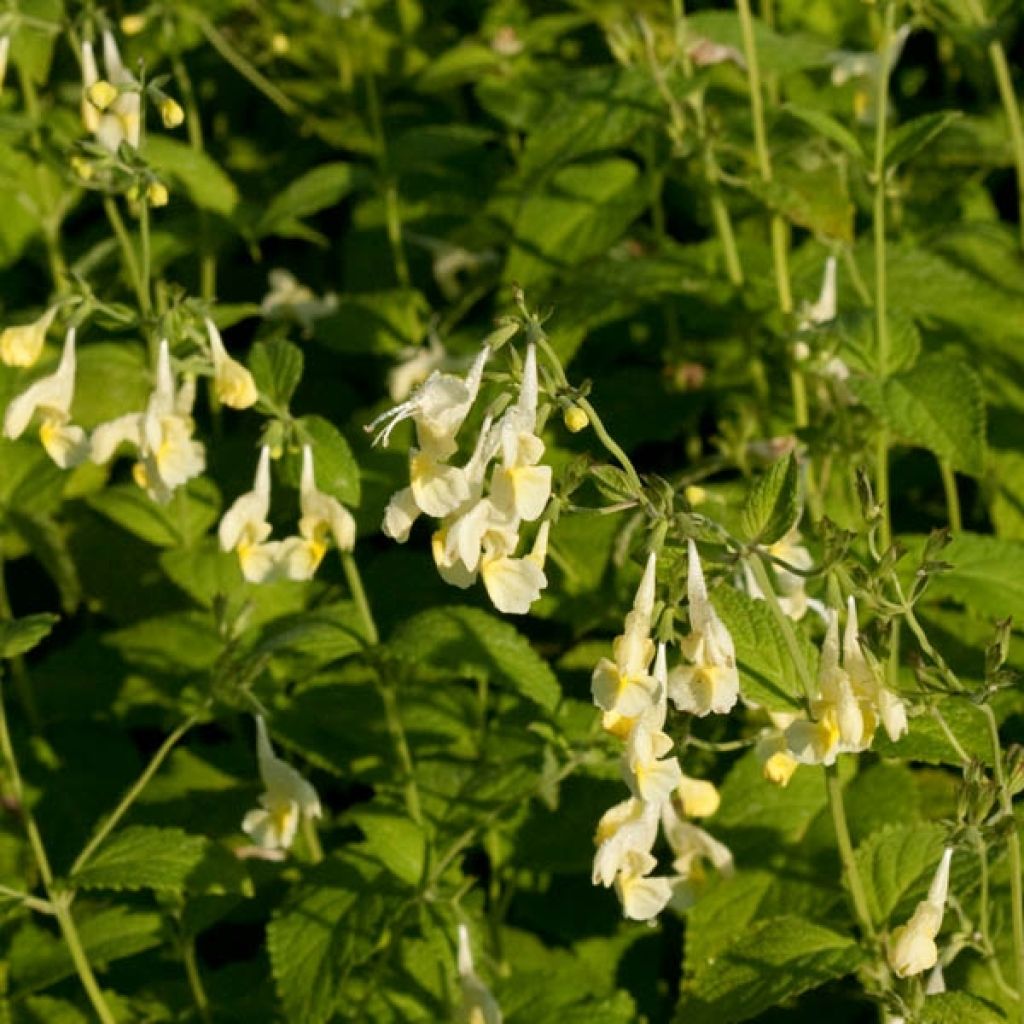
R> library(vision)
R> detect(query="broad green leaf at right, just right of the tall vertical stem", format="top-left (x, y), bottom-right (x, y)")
top-left (850, 355), bottom-right (985, 476)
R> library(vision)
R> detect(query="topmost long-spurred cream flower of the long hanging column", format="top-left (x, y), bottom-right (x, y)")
top-left (591, 552), bottom-right (657, 728)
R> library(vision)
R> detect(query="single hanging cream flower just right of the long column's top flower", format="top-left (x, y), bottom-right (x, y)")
top-left (669, 540), bottom-right (739, 718)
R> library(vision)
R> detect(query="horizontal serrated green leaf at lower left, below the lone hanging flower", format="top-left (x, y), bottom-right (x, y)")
top-left (69, 825), bottom-right (247, 892)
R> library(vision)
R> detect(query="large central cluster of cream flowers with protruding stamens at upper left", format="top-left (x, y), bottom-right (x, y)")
top-left (369, 345), bottom-right (551, 614)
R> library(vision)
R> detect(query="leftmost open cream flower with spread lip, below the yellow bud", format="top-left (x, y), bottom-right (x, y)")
top-left (3, 328), bottom-right (89, 469)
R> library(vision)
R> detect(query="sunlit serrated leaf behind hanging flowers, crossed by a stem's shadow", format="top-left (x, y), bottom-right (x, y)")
top-left (712, 587), bottom-right (817, 711)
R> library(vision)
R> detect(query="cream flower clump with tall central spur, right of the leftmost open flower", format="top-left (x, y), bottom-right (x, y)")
top-left (92, 339), bottom-right (206, 504)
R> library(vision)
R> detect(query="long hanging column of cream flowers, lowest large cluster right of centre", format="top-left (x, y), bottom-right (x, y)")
top-left (591, 554), bottom-right (734, 921)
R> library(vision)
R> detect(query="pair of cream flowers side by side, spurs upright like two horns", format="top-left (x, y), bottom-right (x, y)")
top-left (218, 444), bottom-right (355, 583)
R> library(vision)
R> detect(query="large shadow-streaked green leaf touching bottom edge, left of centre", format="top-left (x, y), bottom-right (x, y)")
top-left (266, 856), bottom-right (395, 1024)
